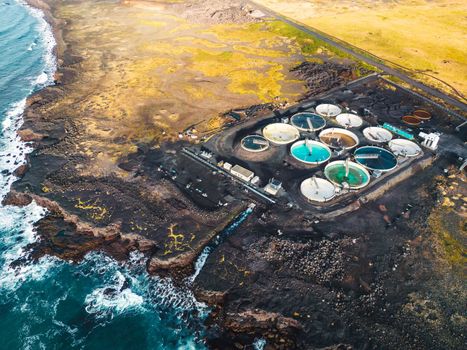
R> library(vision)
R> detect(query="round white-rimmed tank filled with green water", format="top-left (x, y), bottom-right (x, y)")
top-left (324, 160), bottom-right (370, 190)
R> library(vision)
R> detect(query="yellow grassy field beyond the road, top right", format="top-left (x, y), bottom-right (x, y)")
top-left (256, 0), bottom-right (467, 96)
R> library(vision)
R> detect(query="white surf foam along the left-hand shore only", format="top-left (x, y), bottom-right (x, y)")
top-left (0, 1), bottom-right (56, 291)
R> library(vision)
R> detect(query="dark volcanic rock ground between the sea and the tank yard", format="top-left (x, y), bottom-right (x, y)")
top-left (7, 0), bottom-right (465, 349)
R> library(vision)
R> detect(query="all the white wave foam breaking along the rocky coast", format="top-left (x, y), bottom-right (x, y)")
top-left (0, 2), bottom-right (209, 348)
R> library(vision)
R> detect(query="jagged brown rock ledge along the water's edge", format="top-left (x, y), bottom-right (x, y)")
top-left (10, 0), bottom-right (314, 348)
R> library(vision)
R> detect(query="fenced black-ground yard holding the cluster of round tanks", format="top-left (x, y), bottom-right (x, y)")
top-left (169, 75), bottom-right (460, 217)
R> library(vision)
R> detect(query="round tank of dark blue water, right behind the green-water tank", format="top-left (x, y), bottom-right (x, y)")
top-left (354, 146), bottom-right (397, 171)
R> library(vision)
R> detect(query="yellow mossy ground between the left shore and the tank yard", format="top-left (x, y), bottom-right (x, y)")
top-left (51, 1), bottom-right (358, 175)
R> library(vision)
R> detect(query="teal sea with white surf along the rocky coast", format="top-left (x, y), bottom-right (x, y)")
top-left (0, 0), bottom-right (209, 350)
